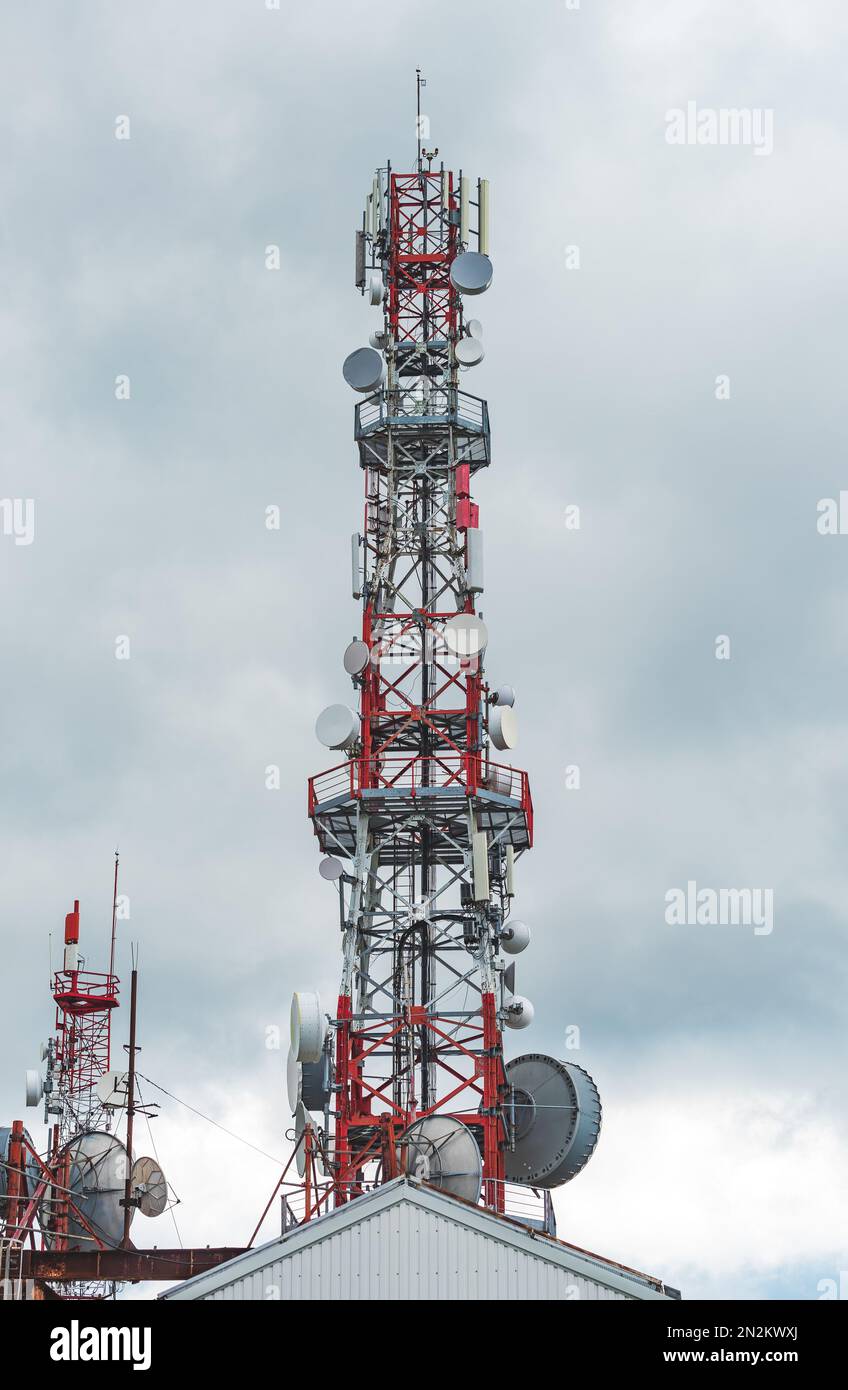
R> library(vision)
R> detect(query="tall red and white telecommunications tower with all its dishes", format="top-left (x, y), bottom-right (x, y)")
top-left (288, 76), bottom-right (601, 1218)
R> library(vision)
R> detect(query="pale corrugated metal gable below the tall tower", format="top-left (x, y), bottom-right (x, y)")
top-left (161, 1177), bottom-right (670, 1302)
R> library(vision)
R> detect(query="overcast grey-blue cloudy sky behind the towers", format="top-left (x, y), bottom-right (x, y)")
top-left (0, 0), bottom-right (848, 1298)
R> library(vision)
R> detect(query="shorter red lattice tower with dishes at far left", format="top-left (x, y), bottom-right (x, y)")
top-left (0, 872), bottom-right (168, 1298)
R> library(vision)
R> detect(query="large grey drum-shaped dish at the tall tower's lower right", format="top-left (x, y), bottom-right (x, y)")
top-left (506, 1052), bottom-right (601, 1187)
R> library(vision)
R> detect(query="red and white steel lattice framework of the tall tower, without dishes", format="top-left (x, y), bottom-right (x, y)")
top-left (307, 161), bottom-right (532, 1215)
